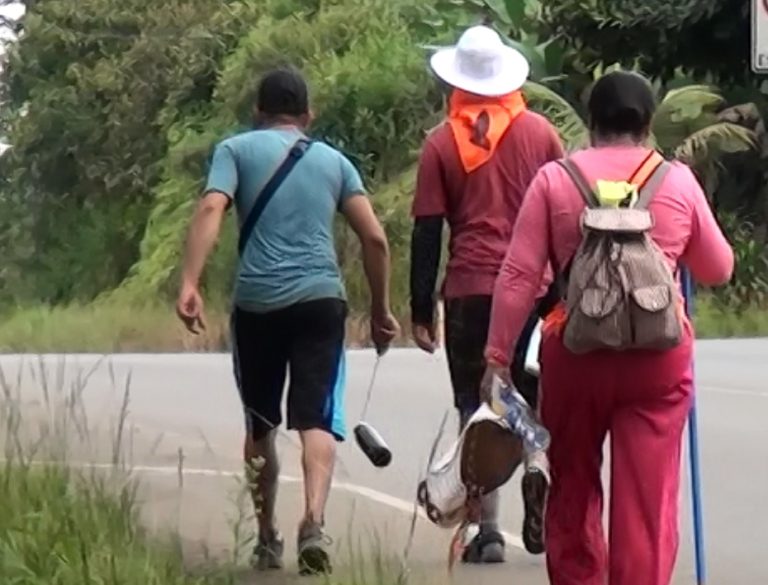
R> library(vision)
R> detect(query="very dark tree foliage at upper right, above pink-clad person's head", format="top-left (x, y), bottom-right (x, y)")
top-left (542, 0), bottom-right (756, 85)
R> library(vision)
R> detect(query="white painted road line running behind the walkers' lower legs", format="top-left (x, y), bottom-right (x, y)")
top-left (83, 463), bottom-right (525, 550)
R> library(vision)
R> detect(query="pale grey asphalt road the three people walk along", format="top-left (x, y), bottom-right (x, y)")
top-left (0, 340), bottom-right (768, 585)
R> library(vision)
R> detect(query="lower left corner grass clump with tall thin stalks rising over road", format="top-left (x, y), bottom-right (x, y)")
top-left (0, 361), bottom-right (233, 585)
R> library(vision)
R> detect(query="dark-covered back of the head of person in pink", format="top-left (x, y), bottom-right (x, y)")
top-left (588, 71), bottom-right (656, 136)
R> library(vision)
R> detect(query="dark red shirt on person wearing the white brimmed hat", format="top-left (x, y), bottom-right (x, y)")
top-left (413, 111), bottom-right (563, 298)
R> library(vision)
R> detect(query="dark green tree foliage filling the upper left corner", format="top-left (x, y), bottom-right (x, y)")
top-left (0, 0), bottom-right (256, 302)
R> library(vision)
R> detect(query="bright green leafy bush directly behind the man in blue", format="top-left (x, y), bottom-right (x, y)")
top-left (111, 0), bottom-right (440, 306)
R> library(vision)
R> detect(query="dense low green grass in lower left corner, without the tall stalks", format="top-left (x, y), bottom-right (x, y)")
top-left (0, 463), bottom-right (230, 585)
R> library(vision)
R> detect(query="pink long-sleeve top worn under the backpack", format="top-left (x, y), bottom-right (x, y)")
top-left (485, 146), bottom-right (733, 365)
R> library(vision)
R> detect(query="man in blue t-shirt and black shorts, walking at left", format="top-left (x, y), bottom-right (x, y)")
top-left (177, 69), bottom-right (399, 573)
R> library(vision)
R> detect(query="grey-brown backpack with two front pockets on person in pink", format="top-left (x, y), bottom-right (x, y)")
top-left (560, 157), bottom-right (683, 354)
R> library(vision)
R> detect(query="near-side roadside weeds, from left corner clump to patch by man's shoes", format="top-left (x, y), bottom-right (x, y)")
top-left (0, 358), bottom-right (412, 585)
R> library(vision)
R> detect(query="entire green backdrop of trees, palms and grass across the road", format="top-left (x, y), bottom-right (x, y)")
top-left (0, 0), bottom-right (768, 352)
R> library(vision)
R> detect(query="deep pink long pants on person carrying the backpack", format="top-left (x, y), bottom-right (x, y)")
top-left (541, 330), bottom-right (693, 585)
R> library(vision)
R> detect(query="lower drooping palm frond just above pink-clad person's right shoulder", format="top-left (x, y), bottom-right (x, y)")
top-left (674, 122), bottom-right (757, 168)
